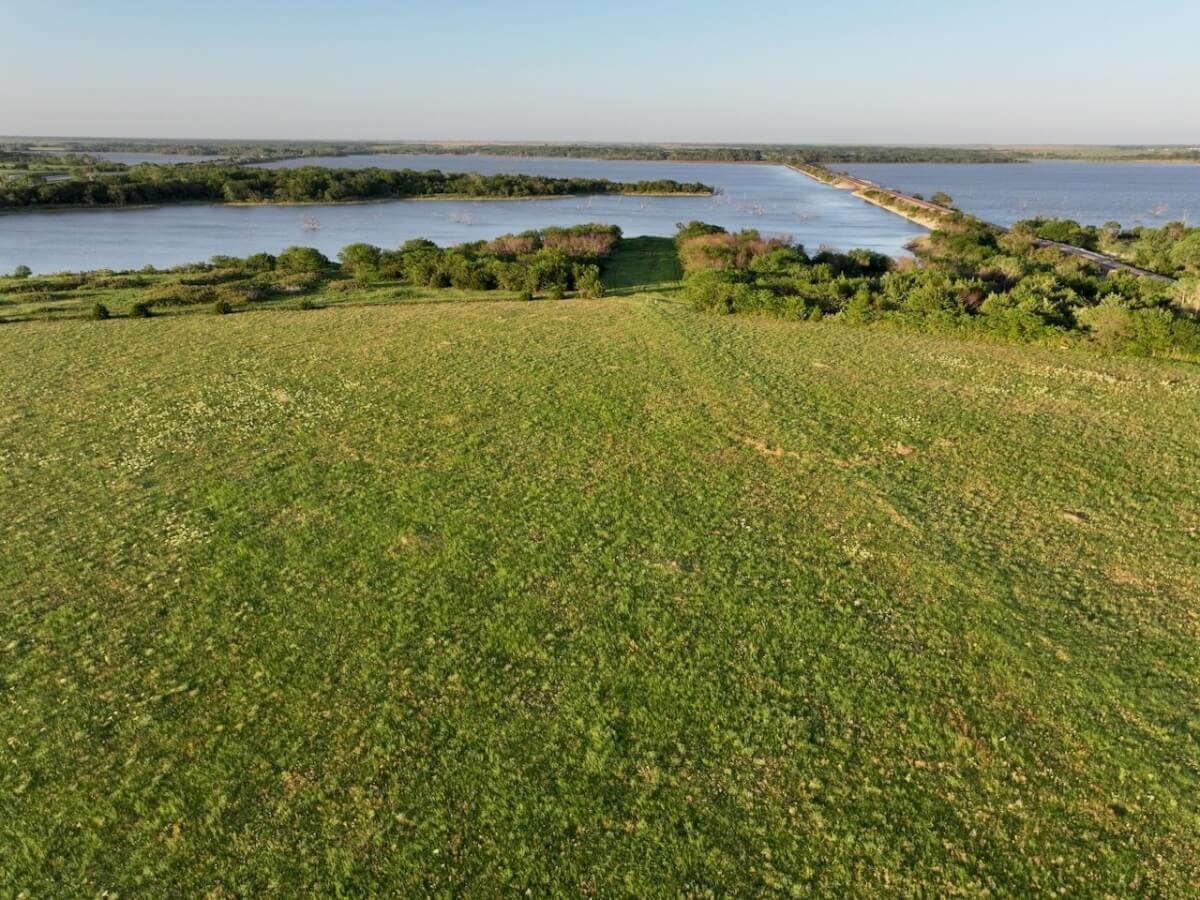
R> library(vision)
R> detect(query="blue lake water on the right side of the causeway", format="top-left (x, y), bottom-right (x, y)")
top-left (832, 161), bottom-right (1200, 228)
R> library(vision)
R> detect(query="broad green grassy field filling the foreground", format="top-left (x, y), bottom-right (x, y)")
top-left (0, 296), bottom-right (1200, 896)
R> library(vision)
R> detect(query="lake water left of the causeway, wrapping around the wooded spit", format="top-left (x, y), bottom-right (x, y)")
top-left (0, 156), bottom-right (925, 274)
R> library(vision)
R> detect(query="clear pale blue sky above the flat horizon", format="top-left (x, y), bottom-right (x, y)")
top-left (0, 0), bottom-right (1200, 144)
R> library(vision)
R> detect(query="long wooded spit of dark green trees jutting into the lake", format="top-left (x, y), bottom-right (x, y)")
top-left (0, 163), bottom-right (713, 209)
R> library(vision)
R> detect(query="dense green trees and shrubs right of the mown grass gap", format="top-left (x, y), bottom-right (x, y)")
top-left (677, 215), bottom-right (1200, 358)
